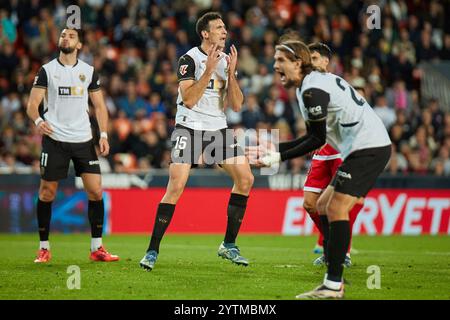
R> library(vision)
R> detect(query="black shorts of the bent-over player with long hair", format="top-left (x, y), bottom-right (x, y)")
top-left (331, 145), bottom-right (391, 197)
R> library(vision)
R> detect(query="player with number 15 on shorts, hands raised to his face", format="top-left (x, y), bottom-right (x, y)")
top-left (140, 12), bottom-right (254, 271)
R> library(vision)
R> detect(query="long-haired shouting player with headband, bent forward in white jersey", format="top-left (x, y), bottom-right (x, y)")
top-left (255, 40), bottom-right (391, 299)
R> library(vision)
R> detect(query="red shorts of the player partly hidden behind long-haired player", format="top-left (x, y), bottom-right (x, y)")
top-left (303, 157), bottom-right (342, 193)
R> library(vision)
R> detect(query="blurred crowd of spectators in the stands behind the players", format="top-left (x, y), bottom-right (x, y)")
top-left (0, 0), bottom-right (450, 176)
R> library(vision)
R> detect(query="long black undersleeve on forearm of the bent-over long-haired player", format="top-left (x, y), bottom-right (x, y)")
top-left (280, 119), bottom-right (327, 161)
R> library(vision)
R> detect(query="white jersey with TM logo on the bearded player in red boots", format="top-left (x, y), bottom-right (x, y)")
top-left (33, 58), bottom-right (100, 143)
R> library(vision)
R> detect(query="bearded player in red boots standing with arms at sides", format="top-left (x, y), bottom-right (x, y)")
top-left (27, 28), bottom-right (119, 263)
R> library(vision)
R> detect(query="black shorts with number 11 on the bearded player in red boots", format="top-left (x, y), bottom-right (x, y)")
top-left (41, 135), bottom-right (100, 181)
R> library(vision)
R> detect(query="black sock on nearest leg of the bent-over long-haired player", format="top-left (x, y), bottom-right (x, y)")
top-left (327, 220), bottom-right (350, 282)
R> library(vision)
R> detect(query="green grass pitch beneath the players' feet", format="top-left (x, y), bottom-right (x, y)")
top-left (0, 234), bottom-right (450, 300)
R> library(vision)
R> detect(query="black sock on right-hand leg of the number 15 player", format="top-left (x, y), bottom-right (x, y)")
top-left (223, 193), bottom-right (248, 243)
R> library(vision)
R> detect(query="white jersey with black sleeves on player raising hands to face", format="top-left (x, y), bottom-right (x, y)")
top-left (175, 47), bottom-right (228, 131)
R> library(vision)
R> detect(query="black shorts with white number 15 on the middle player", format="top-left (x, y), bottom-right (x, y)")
top-left (171, 124), bottom-right (244, 166)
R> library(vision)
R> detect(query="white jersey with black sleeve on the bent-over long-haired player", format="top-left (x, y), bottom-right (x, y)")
top-left (297, 71), bottom-right (391, 159)
